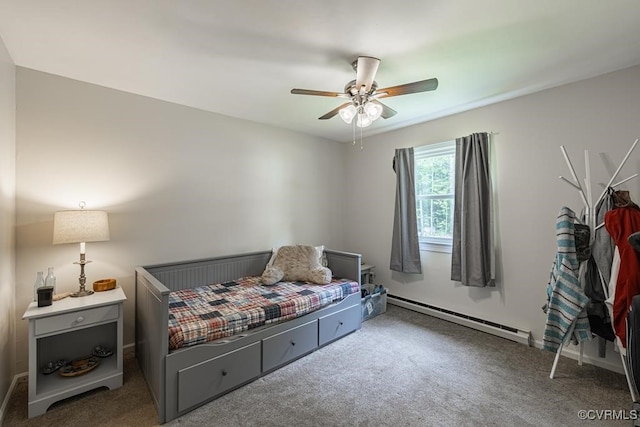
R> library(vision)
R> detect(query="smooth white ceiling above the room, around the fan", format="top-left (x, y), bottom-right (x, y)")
top-left (0, 0), bottom-right (640, 141)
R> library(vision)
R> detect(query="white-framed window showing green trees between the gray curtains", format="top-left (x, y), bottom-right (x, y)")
top-left (413, 141), bottom-right (456, 252)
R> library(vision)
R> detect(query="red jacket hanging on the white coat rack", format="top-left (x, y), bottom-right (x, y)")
top-left (604, 206), bottom-right (640, 348)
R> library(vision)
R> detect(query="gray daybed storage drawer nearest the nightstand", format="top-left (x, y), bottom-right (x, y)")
top-left (178, 342), bottom-right (260, 412)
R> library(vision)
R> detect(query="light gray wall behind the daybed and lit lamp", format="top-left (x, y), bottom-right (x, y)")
top-left (16, 67), bottom-right (346, 372)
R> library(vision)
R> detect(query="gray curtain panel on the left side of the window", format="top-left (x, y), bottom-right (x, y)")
top-left (390, 148), bottom-right (422, 274)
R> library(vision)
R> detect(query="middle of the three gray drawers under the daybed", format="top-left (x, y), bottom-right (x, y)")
top-left (262, 320), bottom-right (318, 372)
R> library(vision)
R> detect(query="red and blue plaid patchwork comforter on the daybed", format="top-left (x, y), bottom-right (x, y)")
top-left (169, 276), bottom-right (360, 350)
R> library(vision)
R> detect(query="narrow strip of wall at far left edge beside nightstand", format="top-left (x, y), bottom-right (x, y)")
top-left (0, 38), bottom-right (16, 419)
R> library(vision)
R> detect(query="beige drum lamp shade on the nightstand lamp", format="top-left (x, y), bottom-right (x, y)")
top-left (53, 209), bottom-right (109, 245)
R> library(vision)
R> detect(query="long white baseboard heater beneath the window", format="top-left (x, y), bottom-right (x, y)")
top-left (387, 294), bottom-right (531, 346)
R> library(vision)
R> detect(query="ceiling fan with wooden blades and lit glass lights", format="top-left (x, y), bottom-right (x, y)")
top-left (291, 56), bottom-right (438, 128)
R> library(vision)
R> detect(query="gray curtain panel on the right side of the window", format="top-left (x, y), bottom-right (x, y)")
top-left (451, 133), bottom-right (495, 287)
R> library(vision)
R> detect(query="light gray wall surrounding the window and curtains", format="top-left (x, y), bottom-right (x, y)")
top-left (345, 67), bottom-right (640, 370)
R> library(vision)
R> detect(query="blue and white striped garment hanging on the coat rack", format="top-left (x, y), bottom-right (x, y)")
top-left (542, 206), bottom-right (591, 352)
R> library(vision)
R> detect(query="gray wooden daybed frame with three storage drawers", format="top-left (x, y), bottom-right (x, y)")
top-left (135, 250), bottom-right (361, 423)
